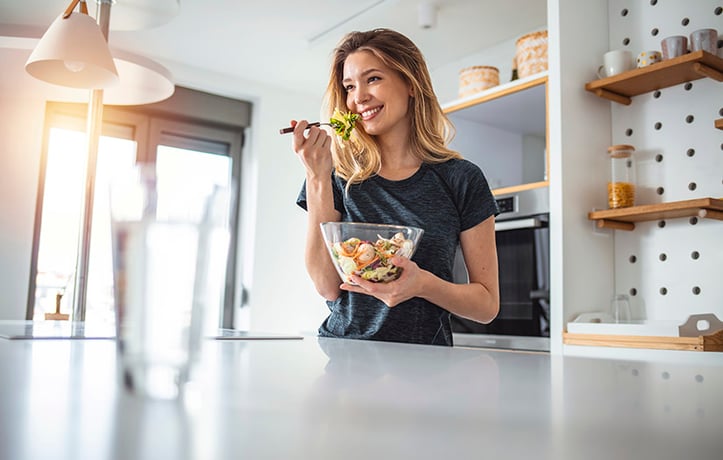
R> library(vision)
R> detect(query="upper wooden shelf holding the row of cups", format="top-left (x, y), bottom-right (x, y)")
top-left (585, 51), bottom-right (723, 105)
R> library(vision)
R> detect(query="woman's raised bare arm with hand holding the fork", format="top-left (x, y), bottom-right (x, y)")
top-left (291, 120), bottom-right (341, 300)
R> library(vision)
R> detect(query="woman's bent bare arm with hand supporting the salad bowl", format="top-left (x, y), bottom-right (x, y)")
top-left (343, 217), bottom-right (500, 323)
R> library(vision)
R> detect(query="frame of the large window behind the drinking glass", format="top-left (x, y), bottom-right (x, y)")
top-left (26, 93), bottom-right (250, 328)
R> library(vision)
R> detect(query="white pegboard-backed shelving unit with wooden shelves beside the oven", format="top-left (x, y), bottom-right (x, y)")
top-left (548, 0), bottom-right (723, 361)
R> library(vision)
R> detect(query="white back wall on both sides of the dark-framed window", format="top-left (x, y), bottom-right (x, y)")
top-left (0, 59), bottom-right (327, 332)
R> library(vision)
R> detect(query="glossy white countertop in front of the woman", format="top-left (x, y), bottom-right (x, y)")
top-left (0, 328), bottom-right (723, 460)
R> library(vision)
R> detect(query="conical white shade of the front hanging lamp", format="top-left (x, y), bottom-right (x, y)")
top-left (25, 13), bottom-right (118, 89)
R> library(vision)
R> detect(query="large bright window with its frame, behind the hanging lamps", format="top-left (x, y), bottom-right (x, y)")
top-left (27, 88), bottom-right (249, 327)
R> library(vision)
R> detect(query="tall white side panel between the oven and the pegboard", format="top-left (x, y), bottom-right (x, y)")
top-left (547, 0), bottom-right (613, 353)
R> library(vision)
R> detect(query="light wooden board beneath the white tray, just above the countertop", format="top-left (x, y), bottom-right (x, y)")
top-left (562, 331), bottom-right (723, 352)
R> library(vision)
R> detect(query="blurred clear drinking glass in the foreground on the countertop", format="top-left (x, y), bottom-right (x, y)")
top-left (110, 165), bottom-right (230, 399)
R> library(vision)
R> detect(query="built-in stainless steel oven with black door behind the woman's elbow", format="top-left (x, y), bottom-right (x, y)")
top-left (452, 187), bottom-right (550, 351)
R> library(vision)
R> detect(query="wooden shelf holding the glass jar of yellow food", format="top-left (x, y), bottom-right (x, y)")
top-left (588, 198), bottom-right (723, 230)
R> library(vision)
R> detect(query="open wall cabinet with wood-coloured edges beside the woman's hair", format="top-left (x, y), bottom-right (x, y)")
top-left (442, 72), bottom-right (549, 195)
